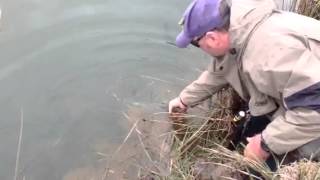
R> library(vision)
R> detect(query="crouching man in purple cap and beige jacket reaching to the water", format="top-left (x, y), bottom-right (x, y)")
top-left (169, 0), bottom-right (320, 162)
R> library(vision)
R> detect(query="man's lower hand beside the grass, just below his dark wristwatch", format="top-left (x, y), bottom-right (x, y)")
top-left (244, 134), bottom-right (270, 162)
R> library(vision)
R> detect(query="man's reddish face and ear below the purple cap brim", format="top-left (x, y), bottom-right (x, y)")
top-left (196, 29), bottom-right (230, 57)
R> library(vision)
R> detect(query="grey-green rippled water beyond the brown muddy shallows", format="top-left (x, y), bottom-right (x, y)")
top-left (0, 0), bottom-right (208, 180)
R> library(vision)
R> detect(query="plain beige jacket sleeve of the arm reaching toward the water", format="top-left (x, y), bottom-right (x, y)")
top-left (180, 59), bottom-right (227, 107)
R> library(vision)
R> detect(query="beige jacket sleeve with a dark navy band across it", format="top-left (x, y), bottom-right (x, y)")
top-left (262, 38), bottom-right (320, 154)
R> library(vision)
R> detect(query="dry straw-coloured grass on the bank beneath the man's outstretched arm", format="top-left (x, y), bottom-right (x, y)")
top-left (135, 89), bottom-right (320, 180)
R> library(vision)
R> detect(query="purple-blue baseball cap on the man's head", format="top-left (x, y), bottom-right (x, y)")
top-left (176, 0), bottom-right (223, 48)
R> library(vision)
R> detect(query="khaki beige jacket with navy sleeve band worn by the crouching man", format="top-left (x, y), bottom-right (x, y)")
top-left (180, 0), bottom-right (320, 154)
